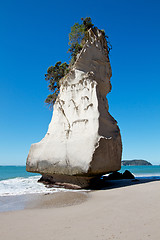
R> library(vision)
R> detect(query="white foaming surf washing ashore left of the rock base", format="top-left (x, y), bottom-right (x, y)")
top-left (0, 176), bottom-right (72, 196)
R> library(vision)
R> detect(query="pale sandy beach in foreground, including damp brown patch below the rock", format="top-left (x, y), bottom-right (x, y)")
top-left (0, 181), bottom-right (160, 240)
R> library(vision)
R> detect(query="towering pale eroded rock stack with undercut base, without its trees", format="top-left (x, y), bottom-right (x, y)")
top-left (27, 29), bottom-right (122, 187)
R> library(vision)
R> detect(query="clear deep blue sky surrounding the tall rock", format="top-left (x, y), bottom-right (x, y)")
top-left (0, 0), bottom-right (160, 165)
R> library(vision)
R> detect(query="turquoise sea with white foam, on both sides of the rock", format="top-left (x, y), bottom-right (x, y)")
top-left (0, 166), bottom-right (160, 197)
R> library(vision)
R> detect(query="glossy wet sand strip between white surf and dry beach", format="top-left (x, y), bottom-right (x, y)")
top-left (0, 191), bottom-right (89, 212)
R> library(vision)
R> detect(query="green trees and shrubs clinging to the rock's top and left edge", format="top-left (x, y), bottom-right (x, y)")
top-left (45, 17), bottom-right (112, 107)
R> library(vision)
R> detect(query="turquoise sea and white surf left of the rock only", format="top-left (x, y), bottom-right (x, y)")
top-left (0, 166), bottom-right (75, 197)
